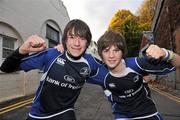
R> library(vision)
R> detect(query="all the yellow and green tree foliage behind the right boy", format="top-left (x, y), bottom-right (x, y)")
top-left (108, 0), bottom-right (157, 56)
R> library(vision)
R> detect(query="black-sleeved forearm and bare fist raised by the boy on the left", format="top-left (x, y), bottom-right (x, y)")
top-left (0, 35), bottom-right (46, 73)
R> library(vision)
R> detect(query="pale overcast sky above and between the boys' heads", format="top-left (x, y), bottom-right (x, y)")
top-left (62, 0), bottom-right (143, 41)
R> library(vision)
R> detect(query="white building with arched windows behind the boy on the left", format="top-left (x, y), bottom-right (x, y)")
top-left (0, 0), bottom-right (70, 102)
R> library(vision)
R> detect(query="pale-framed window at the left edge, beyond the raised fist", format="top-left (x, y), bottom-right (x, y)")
top-left (1, 35), bottom-right (16, 58)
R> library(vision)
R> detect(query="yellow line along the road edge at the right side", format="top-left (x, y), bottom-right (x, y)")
top-left (151, 86), bottom-right (180, 103)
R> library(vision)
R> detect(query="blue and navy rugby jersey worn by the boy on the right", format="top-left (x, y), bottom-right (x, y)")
top-left (92, 57), bottom-right (175, 119)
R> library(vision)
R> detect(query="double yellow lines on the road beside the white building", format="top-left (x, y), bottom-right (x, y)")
top-left (0, 98), bottom-right (33, 115)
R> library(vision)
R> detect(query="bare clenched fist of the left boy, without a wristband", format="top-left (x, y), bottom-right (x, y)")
top-left (19, 35), bottom-right (46, 54)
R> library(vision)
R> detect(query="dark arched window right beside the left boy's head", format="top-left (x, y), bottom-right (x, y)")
top-left (46, 24), bottom-right (59, 47)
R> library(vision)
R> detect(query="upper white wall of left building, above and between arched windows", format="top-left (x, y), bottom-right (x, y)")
top-left (0, 0), bottom-right (69, 40)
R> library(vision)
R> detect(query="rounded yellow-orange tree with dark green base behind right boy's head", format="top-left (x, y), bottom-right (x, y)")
top-left (108, 10), bottom-right (142, 56)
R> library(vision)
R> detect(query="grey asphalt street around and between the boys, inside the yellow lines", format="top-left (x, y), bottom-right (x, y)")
top-left (0, 84), bottom-right (180, 120)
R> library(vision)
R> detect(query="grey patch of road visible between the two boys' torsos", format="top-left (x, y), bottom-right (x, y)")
top-left (75, 84), bottom-right (113, 120)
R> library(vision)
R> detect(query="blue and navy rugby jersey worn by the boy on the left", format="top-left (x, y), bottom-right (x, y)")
top-left (2, 48), bottom-right (101, 119)
